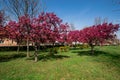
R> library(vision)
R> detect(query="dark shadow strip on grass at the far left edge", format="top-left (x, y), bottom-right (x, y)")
top-left (0, 53), bottom-right (26, 62)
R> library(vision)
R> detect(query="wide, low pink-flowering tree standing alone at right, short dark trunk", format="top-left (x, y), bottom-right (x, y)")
top-left (79, 23), bottom-right (119, 54)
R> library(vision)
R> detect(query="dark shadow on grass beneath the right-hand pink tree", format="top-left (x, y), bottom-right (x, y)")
top-left (72, 50), bottom-right (120, 70)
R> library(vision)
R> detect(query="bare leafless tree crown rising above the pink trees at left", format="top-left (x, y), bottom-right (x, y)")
top-left (1, 0), bottom-right (43, 19)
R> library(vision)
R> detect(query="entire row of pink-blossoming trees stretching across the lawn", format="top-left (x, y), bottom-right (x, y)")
top-left (0, 13), bottom-right (119, 61)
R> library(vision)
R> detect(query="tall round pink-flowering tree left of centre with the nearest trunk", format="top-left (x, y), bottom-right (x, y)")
top-left (30, 13), bottom-right (67, 62)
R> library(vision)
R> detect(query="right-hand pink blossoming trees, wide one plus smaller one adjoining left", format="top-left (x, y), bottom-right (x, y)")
top-left (68, 23), bottom-right (120, 54)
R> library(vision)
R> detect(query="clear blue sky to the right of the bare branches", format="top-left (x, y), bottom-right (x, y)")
top-left (44, 0), bottom-right (120, 37)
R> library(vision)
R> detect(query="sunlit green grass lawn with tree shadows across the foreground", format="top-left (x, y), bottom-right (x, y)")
top-left (0, 46), bottom-right (120, 80)
